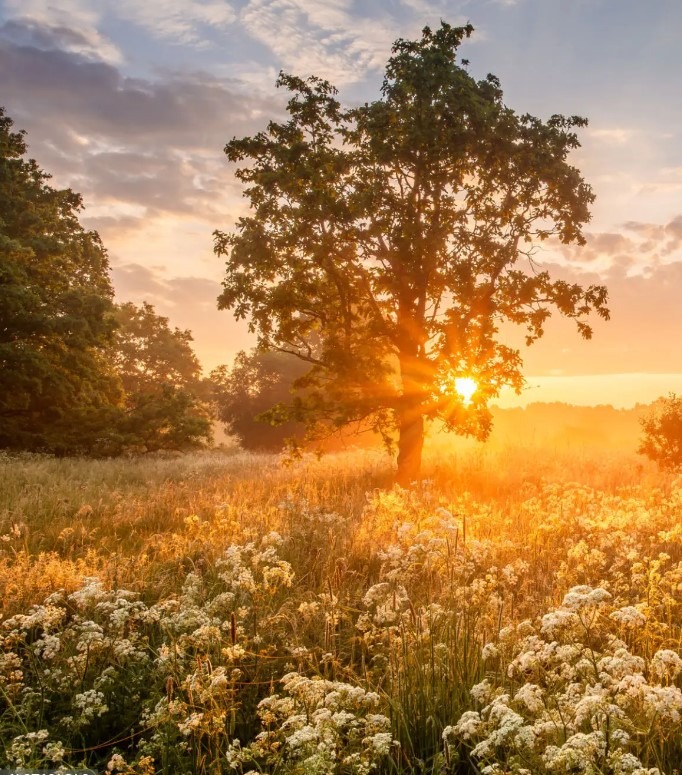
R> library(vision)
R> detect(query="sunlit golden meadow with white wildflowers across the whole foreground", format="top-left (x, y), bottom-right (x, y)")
top-left (0, 445), bottom-right (682, 775)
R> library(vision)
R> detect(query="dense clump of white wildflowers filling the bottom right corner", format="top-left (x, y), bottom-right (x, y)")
top-left (443, 585), bottom-right (682, 775)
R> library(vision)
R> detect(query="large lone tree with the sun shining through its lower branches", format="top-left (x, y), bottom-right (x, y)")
top-left (214, 23), bottom-right (608, 484)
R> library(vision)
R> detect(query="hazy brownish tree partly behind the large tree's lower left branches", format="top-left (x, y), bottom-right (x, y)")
top-left (210, 350), bottom-right (308, 451)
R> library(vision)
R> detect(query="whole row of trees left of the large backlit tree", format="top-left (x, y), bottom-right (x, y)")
top-left (0, 103), bottom-right (295, 457)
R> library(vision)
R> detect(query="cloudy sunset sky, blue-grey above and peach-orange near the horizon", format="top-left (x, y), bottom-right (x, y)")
top-left (0, 0), bottom-right (682, 406)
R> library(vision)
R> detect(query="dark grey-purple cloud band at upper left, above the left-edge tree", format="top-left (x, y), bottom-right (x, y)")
top-left (0, 23), bottom-right (264, 148)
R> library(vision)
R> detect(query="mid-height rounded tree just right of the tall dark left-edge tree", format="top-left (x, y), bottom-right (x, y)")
top-left (109, 302), bottom-right (211, 454)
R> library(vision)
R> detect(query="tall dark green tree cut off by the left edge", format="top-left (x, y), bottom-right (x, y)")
top-left (0, 108), bottom-right (120, 452)
